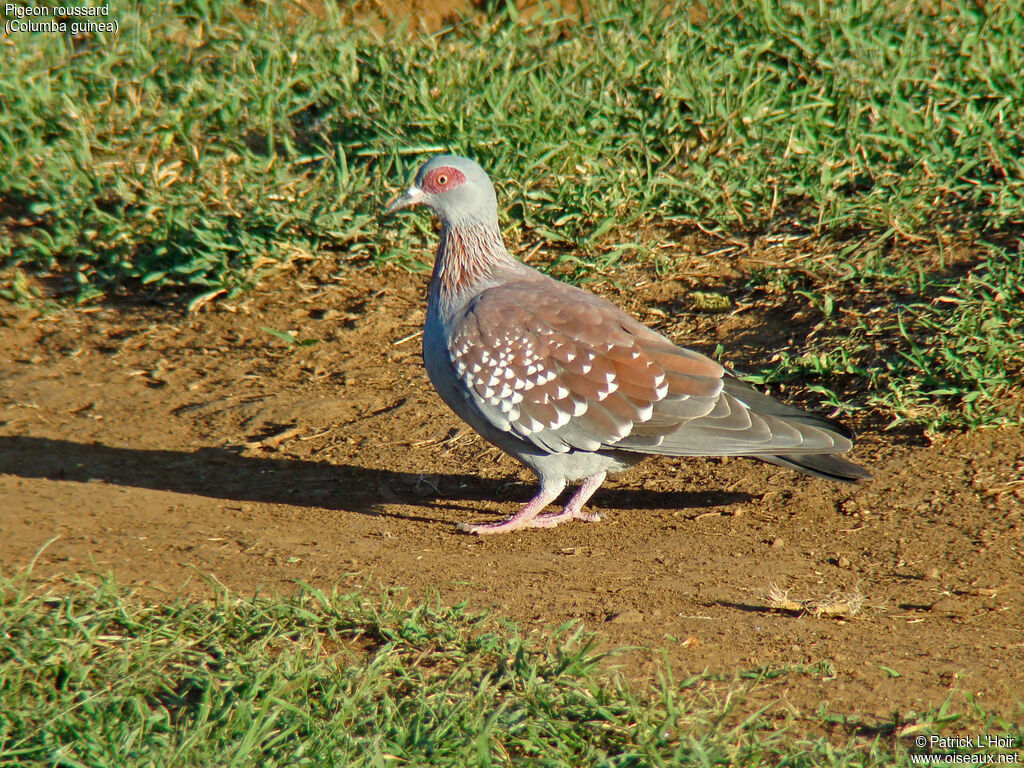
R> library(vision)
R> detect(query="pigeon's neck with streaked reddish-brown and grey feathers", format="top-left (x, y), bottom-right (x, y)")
top-left (430, 222), bottom-right (514, 305)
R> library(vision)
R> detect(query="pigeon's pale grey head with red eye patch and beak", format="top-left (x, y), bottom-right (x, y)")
top-left (386, 155), bottom-right (498, 228)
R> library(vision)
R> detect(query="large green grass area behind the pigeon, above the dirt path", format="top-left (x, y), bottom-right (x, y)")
top-left (0, 0), bottom-right (1024, 427)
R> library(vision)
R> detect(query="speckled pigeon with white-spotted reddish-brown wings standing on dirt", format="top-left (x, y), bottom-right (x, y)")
top-left (387, 156), bottom-right (870, 534)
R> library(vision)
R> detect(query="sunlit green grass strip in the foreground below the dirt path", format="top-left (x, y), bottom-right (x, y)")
top-left (0, 573), bottom-right (1024, 768)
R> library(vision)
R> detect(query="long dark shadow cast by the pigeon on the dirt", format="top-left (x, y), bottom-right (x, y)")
top-left (0, 436), bottom-right (752, 522)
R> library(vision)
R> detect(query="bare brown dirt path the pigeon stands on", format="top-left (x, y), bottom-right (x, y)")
top-left (0, 241), bottom-right (1024, 729)
